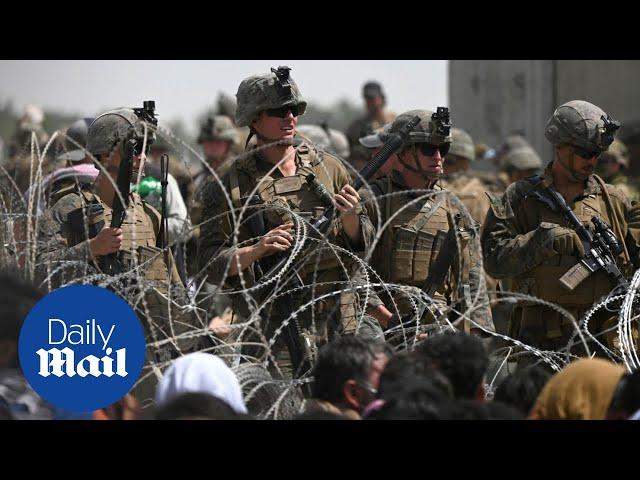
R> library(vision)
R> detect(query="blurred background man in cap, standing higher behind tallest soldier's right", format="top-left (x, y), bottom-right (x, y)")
top-left (346, 82), bottom-right (396, 165)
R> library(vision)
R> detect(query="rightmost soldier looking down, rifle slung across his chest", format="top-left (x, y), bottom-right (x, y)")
top-left (482, 100), bottom-right (640, 362)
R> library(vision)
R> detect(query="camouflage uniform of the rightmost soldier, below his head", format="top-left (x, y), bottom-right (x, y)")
top-left (482, 167), bottom-right (640, 356)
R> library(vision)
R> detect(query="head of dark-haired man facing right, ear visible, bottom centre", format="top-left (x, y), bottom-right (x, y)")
top-left (312, 336), bottom-right (389, 414)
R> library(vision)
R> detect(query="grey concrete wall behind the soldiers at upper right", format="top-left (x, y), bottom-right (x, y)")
top-left (449, 60), bottom-right (640, 170)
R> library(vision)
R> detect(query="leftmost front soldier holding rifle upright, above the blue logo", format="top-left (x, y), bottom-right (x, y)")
top-left (36, 103), bottom-right (198, 401)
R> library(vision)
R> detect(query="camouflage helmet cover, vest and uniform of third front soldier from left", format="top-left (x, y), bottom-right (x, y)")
top-left (360, 110), bottom-right (494, 338)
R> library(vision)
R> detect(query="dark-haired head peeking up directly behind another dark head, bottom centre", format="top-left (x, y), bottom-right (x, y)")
top-left (378, 351), bottom-right (453, 400)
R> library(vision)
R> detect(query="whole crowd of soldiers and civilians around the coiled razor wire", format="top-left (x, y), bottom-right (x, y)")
top-left (0, 67), bottom-right (640, 420)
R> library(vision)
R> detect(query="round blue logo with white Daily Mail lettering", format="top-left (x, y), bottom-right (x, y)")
top-left (18, 285), bottom-right (145, 412)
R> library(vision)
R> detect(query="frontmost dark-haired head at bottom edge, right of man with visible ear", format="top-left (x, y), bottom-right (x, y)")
top-left (365, 376), bottom-right (451, 420)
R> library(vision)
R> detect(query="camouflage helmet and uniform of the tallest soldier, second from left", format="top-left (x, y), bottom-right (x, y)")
top-left (198, 67), bottom-right (368, 375)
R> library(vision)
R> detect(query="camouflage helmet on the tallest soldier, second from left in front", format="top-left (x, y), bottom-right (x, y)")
top-left (236, 67), bottom-right (307, 127)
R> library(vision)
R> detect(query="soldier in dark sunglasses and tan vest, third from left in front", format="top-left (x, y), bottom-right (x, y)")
top-left (359, 110), bottom-right (494, 340)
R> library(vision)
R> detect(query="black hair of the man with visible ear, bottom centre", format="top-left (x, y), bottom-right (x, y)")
top-left (312, 337), bottom-right (378, 403)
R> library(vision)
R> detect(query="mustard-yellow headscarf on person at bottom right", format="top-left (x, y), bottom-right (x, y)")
top-left (529, 358), bottom-right (625, 420)
